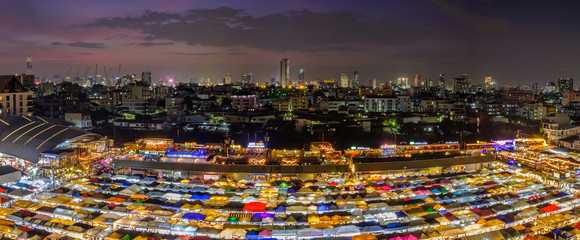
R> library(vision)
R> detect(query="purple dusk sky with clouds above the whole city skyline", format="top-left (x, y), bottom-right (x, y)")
top-left (0, 0), bottom-right (580, 85)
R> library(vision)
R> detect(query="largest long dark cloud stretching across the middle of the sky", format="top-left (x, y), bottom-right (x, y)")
top-left (82, 7), bottom-right (419, 52)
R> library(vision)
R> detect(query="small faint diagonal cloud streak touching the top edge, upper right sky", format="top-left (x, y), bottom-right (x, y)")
top-left (430, 0), bottom-right (508, 31)
